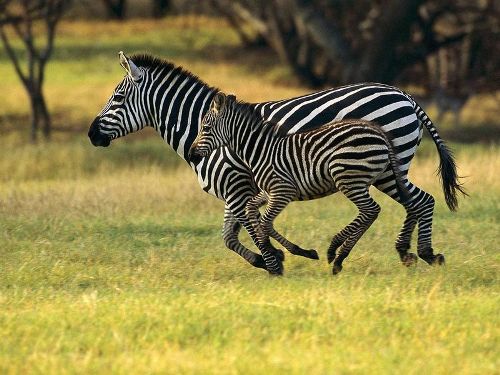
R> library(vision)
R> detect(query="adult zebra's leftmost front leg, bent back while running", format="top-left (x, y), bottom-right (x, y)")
top-left (222, 204), bottom-right (266, 269)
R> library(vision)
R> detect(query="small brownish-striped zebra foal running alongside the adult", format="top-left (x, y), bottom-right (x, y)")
top-left (190, 92), bottom-right (409, 274)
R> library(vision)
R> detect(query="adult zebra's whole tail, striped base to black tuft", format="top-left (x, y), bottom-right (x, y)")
top-left (411, 98), bottom-right (468, 211)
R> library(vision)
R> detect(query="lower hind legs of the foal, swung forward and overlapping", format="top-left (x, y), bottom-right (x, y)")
top-left (328, 186), bottom-right (380, 275)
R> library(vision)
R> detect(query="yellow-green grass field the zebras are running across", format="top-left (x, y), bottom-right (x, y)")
top-left (0, 16), bottom-right (500, 374)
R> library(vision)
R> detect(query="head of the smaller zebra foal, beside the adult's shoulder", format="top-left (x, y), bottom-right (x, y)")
top-left (189, 92), bottom-right (236, 158)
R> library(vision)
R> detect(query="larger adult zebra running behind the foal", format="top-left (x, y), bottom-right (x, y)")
top-left (88, 52), bottom-right (462, 276)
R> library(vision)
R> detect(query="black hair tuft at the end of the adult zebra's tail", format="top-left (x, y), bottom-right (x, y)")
top-left (437, 143), bottom-right (468, 211)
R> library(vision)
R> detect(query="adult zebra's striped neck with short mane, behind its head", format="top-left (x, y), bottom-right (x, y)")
top-left (149, 68), bottom-right (217, 162)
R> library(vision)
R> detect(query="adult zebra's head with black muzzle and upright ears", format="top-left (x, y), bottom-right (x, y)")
top-left (88, 51), bottom-right (150, 147)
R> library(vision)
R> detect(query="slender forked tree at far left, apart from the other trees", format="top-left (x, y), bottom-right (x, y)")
top-left (0, 0), bottom-right (69, 141)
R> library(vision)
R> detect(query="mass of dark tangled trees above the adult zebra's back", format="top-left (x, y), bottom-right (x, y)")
top-left (211, 0), bottom-right (500, 111)
